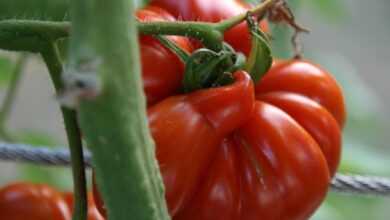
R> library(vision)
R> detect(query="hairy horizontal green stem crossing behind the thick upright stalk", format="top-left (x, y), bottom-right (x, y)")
top-left (0, 20), bottom-right (223, 52)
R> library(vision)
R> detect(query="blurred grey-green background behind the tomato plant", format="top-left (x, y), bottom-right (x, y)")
top-left (0, 0), bottom-right (390, 220)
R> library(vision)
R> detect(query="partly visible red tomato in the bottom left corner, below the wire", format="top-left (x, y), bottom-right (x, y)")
top-left (0, 183), bottom-right (71, 220)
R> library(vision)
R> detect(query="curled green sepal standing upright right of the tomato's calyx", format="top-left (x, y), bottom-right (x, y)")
top-left (245, 17), bottom-right (272, 82)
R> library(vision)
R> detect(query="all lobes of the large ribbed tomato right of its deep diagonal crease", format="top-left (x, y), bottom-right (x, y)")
top-left (174, 60), bottom-right (345, 220)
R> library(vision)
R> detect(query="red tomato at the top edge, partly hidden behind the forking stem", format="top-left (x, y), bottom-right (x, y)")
top-left (151, 0), bottom-right (268, 55)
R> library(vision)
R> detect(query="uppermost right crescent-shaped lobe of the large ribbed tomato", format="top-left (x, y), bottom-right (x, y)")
top-left (255, 60), bottom-right (346, 128)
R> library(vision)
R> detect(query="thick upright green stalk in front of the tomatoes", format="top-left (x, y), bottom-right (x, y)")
top-left (69, 0), bottom-right (169, 220)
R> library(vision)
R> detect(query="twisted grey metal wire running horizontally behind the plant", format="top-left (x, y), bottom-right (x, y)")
top-left (0, 142), bottom-right (390, 196)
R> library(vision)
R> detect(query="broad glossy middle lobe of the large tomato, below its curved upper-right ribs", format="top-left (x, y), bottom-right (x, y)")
top-left (173, 101), bottom-right (330, 220)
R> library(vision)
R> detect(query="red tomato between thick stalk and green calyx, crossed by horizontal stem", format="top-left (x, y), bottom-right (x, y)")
top-left (136, 6), bottom-right (192, 105)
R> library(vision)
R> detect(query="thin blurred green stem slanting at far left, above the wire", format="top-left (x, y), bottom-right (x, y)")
top-left (0, 54), bottom-right (27, 142)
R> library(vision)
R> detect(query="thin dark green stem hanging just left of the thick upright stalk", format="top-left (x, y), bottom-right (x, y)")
top-left (41, 42), bottom-right (88, 220)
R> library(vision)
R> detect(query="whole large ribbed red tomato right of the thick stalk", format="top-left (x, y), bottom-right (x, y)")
top-left (95, 60), bottom-right (345, 220)
